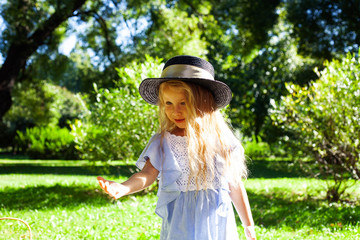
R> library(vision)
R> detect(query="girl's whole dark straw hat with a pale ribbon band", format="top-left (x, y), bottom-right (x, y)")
top-left (139, 55), bottom-right (231, 108)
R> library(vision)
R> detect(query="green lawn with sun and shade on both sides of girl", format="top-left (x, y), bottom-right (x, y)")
top-left (0, 159), bottom-right (360, 240)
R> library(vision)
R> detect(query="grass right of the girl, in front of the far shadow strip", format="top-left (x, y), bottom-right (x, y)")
top-left (246, 178), bottom-right (360, 240)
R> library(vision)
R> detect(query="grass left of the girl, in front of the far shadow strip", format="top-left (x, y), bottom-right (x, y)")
top-left (0, 174), bottom-right (161, 239)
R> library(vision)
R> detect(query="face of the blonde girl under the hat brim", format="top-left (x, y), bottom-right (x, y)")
top-left (163, 87), bottom-right (188, 129)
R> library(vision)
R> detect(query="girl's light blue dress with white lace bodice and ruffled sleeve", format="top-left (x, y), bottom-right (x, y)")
top-left (136, 132), bottom-right (238, 240)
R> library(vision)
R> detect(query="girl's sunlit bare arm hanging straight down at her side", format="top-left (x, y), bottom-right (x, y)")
top-left (229, 182), bottom-right (256, 240)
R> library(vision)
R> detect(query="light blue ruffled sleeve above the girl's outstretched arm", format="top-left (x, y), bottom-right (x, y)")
top-left (136, 134), bottom-right (181, 219)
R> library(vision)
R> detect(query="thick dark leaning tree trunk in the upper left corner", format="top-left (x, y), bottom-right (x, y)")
top-left (0, 0), bottom-right (86, 121)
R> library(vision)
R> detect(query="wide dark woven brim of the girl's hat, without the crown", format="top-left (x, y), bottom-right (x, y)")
top-left (139, 78), bottom-right (232, 108)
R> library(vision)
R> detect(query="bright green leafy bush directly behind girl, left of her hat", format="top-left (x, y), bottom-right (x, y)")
top-left (71, 57), bottom-right (161, 161)
